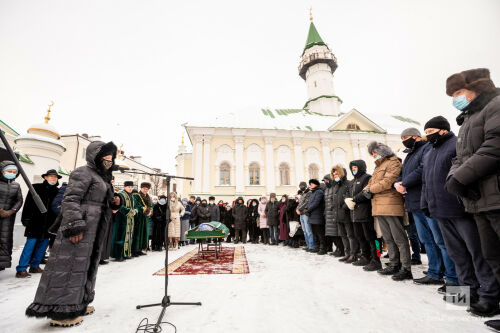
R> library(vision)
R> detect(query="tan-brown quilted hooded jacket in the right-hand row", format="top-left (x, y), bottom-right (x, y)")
top-left (365, 142), bottom-right (405, 216)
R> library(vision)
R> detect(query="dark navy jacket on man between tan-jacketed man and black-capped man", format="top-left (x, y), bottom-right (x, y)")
top-left (396, 141), bottom-right (431, 212)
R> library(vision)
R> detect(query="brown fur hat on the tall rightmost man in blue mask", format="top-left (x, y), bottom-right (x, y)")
top-left (446, 68), bottom-right (495, 96)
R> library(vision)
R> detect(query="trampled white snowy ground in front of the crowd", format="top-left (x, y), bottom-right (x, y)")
top-left (0, 244), bottom-right (489, 333)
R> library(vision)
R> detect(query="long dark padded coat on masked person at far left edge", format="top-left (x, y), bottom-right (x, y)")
top-left (0, 161), bottom-right (23, 269)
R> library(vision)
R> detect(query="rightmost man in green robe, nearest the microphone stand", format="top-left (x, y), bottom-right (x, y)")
top-left (132, 182), bottom-right (153, 257)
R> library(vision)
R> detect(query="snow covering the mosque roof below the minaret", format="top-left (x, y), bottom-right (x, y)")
top-left (186, 108), bottom-right (420, 134)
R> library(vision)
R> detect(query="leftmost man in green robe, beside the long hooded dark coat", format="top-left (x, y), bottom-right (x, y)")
top-left (111, 181), bottom-right (137, 261)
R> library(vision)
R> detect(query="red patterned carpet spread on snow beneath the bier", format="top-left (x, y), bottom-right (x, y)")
top-left (153, 246), bottom-right (250, 275)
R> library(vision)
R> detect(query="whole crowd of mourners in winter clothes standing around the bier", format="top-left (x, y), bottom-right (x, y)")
top-left (0, 69), bottom-right (500, 330)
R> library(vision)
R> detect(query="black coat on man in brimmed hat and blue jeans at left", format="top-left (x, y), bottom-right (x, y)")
top-left (21, 180), bottom-right (59, 239)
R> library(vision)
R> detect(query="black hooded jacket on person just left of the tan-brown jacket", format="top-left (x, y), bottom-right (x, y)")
top-left (348, 160), bottom-right (373, 222)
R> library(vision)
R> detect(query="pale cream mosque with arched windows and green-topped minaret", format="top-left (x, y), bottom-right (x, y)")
top-left (176, 18), bottom-right (420, 200)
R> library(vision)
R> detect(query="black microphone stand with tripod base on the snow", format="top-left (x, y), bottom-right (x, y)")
top-left (123, 171), bottom-right (201, 333)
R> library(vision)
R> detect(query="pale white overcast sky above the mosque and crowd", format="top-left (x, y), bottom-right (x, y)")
top-left (0, 0), bottom-right (500, 172)
